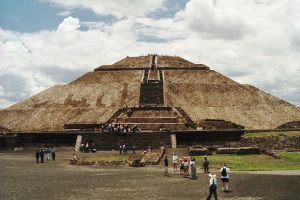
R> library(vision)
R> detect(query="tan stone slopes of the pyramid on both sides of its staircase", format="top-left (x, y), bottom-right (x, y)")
top-left (0, 55), bottom-right (300, 132)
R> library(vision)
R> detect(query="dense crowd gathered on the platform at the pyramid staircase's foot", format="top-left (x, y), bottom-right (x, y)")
top-left (102, 123), bottom-right (141, 135)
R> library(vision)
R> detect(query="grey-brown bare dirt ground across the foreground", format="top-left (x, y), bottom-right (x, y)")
top-left (0, 149), bottom-right (300, 200)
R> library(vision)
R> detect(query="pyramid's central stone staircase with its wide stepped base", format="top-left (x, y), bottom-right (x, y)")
top-left (108, 55), bottom-right (196, 131)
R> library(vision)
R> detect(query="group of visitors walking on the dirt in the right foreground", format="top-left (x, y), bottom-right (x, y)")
top-left (164, 153), bottom-right (230, 200)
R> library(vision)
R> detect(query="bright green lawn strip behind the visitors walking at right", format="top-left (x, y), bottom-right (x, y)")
top-left (196, 152), bottom-right (300, 171)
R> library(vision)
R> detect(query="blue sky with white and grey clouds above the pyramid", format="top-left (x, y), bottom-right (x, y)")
top-left (0, 0), bottom-right (300, 109)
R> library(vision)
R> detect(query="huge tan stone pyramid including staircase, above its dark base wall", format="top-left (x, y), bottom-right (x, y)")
top-left (0, 55), bottom-right (300, 132)
